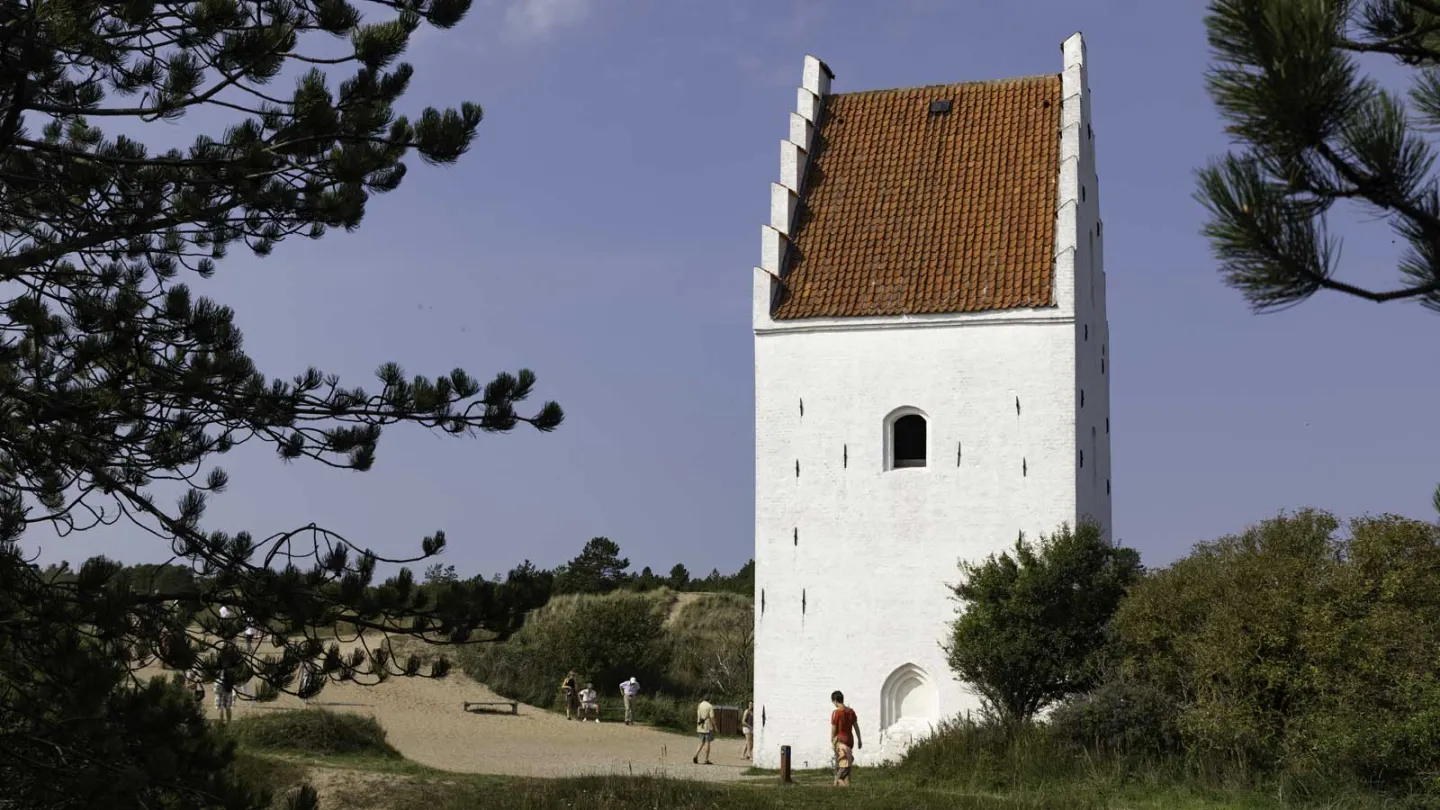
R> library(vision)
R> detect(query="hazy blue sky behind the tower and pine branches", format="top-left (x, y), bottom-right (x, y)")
top-left (33, 0), bottom-right (1440, 574)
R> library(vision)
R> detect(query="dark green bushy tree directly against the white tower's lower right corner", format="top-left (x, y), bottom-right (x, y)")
top-left (945, 522), bottom-right (1142, 724)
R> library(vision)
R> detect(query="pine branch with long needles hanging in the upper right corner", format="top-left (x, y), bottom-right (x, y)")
top-left (1197, 0), bottom-right (1440, 512)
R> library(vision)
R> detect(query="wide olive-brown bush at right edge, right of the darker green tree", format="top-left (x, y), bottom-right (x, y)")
top-left (1115, 510), bottom-right (1440, 783)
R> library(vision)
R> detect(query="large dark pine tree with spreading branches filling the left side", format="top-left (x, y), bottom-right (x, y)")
top-left (0, 0), bottom-right (562, 807)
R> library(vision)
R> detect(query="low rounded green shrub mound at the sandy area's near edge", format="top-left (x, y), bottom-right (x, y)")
top-left (229, 709), bottom-right (400, 760)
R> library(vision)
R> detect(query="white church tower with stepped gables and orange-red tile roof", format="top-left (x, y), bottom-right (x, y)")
top-left (755, 33), bottom-right (1110, 770)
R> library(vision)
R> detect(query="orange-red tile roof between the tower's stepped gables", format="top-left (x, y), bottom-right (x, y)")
top-left (773, 75), bottom-right (1060, 320)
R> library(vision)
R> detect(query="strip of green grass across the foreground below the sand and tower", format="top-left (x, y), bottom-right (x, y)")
top-left (229, 709), bottom-right (1431, 810)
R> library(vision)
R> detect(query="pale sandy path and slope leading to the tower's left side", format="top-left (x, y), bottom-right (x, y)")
top-left (141, 634), bottom-right (749, 781)
